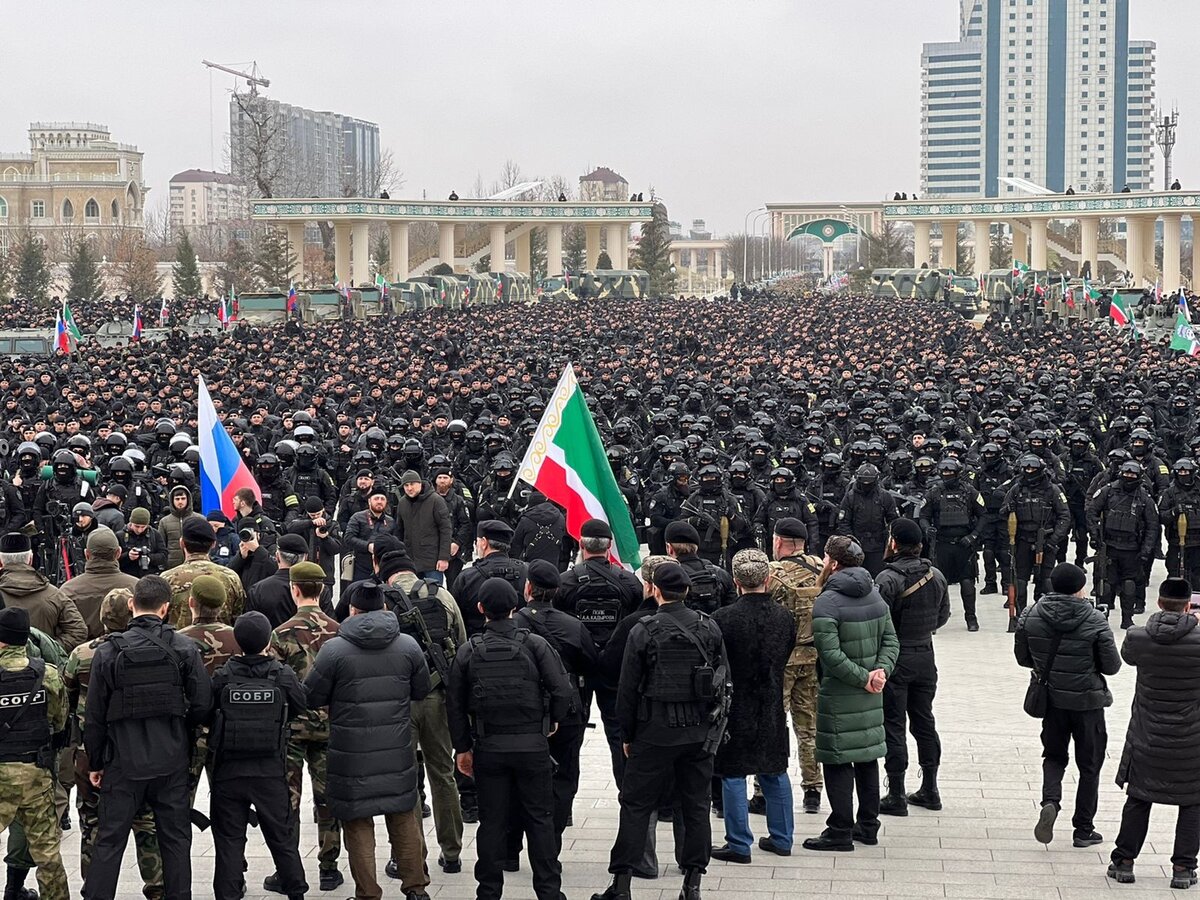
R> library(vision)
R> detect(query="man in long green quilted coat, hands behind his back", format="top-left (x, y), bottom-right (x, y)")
top-left (804, 535), bottom-right (900, 851)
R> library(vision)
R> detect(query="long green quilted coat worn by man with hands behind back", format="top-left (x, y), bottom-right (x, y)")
top-left (812, 568), bottom-right (900, 764)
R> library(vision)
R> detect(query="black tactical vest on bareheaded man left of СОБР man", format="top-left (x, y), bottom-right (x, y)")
top-left (108, 630), bottom-right (187, 722)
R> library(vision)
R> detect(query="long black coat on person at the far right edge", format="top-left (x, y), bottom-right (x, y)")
top-left (1117, 612), bottom-right (1200, 806)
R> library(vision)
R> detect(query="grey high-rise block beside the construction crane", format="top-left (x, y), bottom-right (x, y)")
top-left (229, 94), bottom-right (379, 197)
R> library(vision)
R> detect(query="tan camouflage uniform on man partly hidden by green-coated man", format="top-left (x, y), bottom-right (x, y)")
top-left (770, 556), bottom-right (823, 791)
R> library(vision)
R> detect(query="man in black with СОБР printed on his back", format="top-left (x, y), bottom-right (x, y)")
top-left (209, 612), bottom-right (308, 900)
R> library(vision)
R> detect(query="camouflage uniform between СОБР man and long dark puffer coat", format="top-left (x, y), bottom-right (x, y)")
top-left (271, 606), bottom-right (342, 871)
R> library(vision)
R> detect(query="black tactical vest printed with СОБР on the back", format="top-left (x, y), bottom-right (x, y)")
top-left (211, 660), bottom-right (288, 760)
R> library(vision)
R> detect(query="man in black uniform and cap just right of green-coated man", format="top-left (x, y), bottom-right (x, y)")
top-left (875, 518), bottom-right (950, 816)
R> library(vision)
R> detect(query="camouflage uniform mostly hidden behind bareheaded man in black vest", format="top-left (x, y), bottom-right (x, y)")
top-left (62, 614), bottom-right (164, 900)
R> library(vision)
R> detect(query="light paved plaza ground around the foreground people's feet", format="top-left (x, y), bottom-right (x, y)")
top-left (54, 578), bottom-right (1200, 900)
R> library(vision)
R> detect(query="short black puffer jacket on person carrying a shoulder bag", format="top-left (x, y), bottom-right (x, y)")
top-left (1014, 594), bottom-right (1121, 710)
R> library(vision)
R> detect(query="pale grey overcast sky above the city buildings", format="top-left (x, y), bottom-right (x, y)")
top-left (0, 0), bottom-right (1200, 233)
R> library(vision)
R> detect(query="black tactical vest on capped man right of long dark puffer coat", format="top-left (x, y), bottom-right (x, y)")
top-left (468, 630), bottom-right (546, 738)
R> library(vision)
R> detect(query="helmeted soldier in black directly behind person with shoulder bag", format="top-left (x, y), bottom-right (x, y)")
top-left (1000, 454), bottom-right (1070, 632)
